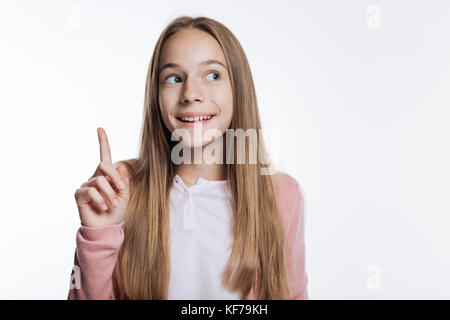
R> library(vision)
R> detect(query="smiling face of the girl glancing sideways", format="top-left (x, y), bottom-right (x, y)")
top-left (158, 29), bottom-right (233, 147)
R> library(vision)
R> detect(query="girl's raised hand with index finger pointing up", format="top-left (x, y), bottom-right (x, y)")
top-left (75, 128), bottom-right (131, 228)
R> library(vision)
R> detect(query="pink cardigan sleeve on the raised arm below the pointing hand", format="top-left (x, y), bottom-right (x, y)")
top-left (67, 222), bottom-right (124, 300)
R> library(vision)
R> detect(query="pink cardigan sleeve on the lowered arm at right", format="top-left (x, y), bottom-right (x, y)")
top-left (280, 174), bottom-right (308, 300)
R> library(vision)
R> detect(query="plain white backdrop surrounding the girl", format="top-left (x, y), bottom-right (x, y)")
top-left (0, 0), bottom-right (450, 299)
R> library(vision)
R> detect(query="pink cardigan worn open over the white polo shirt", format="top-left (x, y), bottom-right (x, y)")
top-left (68, 172), bottom-right (308, 300)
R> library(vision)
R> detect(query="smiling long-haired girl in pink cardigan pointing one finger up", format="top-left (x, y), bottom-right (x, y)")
top-left (68, 16), bottom-right (308, 300)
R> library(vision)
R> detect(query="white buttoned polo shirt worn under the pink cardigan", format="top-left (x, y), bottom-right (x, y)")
top-left (168, 175), bottom-right (240, 300)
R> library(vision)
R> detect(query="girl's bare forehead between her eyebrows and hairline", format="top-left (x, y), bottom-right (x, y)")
top-left (159, 29), bottom-right (226, 67)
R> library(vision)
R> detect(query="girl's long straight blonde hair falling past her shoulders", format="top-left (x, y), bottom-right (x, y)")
top-left (114, 16), bottom-right (290, 300)
